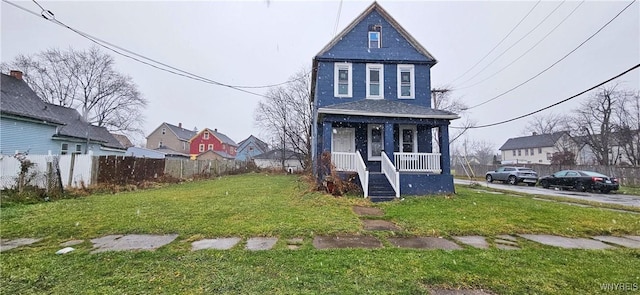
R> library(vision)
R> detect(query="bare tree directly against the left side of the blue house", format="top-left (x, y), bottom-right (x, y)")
top-left (255, 70), bottom-right (313, 169)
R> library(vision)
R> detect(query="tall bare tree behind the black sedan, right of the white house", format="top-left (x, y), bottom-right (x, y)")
top-left (573, 85), bottom-right (621, 165)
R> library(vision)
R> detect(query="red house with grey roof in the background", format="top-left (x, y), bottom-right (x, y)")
top-left (189, 128), bottom-right (238, 159)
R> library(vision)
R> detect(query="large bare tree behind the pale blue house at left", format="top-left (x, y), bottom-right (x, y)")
top-left (1, 47), bottom-right (147, 134)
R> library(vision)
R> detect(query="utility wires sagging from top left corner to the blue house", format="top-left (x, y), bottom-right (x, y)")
top-left (2, 0), bottom-right (308, 92)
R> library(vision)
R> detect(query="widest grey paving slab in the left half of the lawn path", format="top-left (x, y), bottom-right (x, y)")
top-left (91, 235), bottom-right (178, 254)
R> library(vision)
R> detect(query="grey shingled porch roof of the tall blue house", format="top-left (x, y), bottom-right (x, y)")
top-left (318, 99), bottom-right (460, 119)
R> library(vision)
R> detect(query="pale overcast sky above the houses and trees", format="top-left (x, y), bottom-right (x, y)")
top-left (0, 0), bottom-right (640, 152)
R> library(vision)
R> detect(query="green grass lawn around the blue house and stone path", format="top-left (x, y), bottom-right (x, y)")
top-left (0, 174), bottom-right (640, 294)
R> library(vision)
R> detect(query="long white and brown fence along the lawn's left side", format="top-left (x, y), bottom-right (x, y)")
top-left (0, 154), bottom-right (247, 190)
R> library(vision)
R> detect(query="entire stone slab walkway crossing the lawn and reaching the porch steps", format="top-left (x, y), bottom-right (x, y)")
top-left (0, 206), bottom-right (640, 254)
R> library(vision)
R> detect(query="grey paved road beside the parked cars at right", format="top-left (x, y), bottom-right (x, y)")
top-left (453, 179), bottom-right (640, 207)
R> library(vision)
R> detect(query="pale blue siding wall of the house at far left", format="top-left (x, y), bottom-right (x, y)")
top-left (0, 117), bottom-right (60, 155)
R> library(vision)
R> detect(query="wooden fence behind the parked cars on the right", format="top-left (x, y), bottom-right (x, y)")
top-left (451, 164), bottom-right (640, 187)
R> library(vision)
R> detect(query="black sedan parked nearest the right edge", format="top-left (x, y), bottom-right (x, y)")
top-left (540, 170), bottom-right (620, 194)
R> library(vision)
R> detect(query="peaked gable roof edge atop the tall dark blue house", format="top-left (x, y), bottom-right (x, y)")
top-left (316, 2), bottom-right (438, 64)
